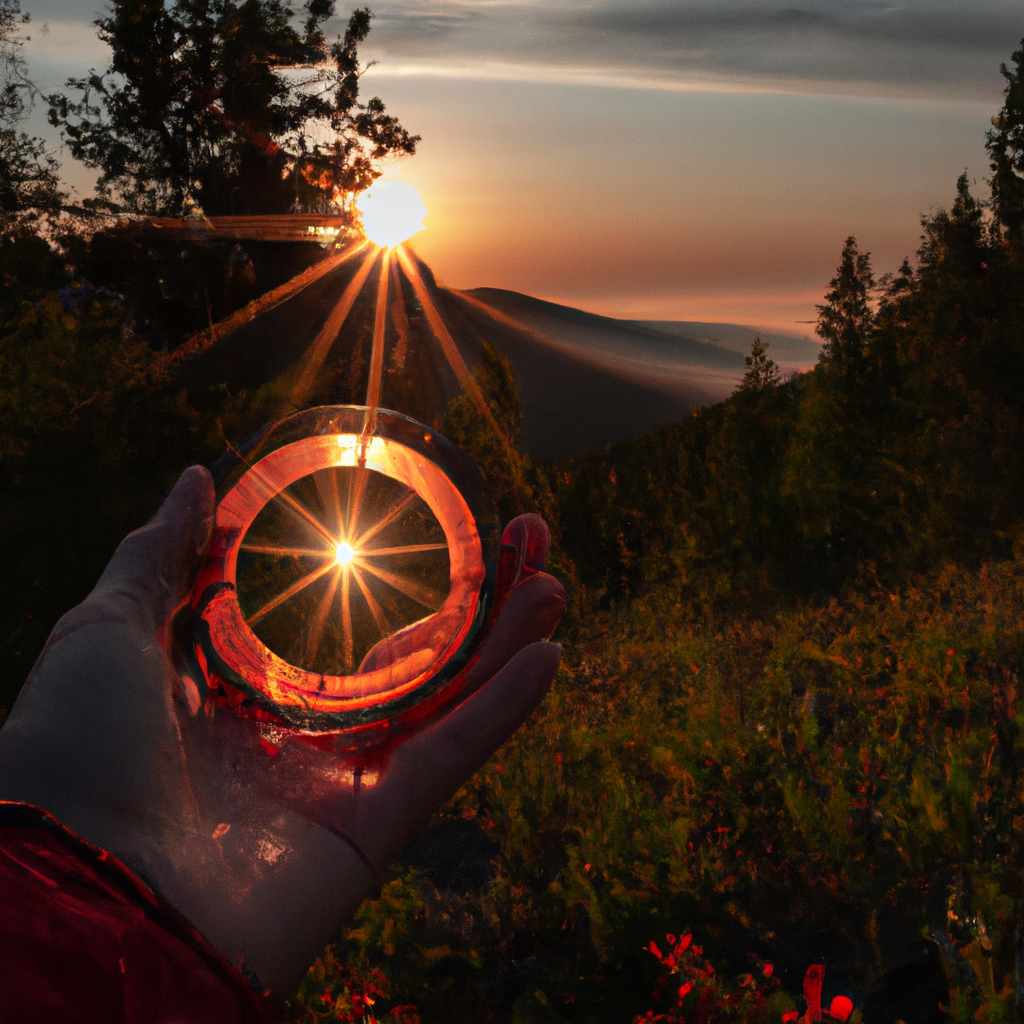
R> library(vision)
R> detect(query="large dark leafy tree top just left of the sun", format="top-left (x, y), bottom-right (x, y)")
top-left (49, 0), bottom-right (419, 214)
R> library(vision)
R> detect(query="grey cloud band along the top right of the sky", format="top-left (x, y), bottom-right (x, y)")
top-left (356, 0), bottom-right (1024, 99)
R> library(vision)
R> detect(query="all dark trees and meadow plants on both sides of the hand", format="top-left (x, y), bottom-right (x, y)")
top-left (0, 0), bottom-right (1024, 1024)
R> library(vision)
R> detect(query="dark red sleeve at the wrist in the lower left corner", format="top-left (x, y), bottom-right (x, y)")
top-left (0, 802), bottom-right (271, 1024)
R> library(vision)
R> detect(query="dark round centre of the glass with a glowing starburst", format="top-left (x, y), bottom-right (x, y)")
top-left (236, 466), bottom-right (451, 676)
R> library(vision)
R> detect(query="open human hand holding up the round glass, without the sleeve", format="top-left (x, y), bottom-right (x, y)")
top-left (0, 467), bottom-right (564, 994)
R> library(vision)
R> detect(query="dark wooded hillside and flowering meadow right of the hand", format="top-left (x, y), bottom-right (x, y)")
top-left (288, 50), bottom-right (1024, 1022)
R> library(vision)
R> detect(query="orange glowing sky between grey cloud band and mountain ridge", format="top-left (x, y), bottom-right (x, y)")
top-left (371, 75), bottom-right (992, 333)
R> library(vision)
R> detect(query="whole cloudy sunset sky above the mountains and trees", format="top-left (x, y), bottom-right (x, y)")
top-left (16, 0), bottom-right (1024, 335)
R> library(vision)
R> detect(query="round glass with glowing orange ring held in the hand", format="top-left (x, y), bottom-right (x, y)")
top-left (191, 406), bottom-right (498, 734)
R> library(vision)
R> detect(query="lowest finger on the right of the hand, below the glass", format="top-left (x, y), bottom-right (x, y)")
top-left (360, 643), bottom-right (562, 864)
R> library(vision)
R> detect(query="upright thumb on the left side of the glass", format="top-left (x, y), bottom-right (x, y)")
top-left (47, 466), bottom-right (214, 646)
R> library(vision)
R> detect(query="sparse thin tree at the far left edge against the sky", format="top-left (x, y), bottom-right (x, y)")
top-left (0, 0), bottom-right (65, 230)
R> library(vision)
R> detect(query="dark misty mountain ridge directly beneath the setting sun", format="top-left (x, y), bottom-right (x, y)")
top-left (183, 253), bottom-right (801, 461)
